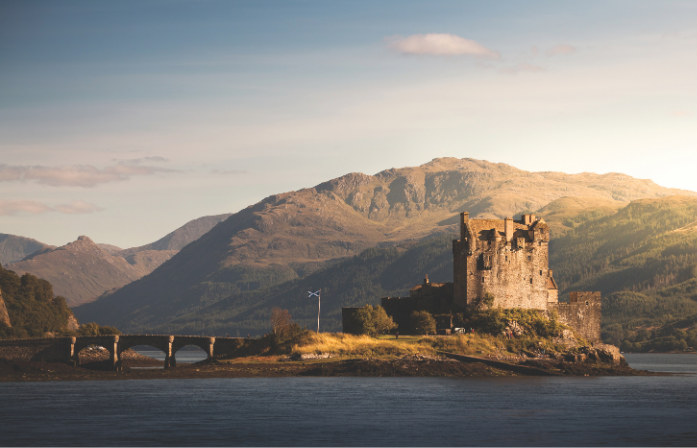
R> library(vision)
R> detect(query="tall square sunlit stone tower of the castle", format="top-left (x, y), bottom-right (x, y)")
top-left (453, 213), bottom-right (558, 310)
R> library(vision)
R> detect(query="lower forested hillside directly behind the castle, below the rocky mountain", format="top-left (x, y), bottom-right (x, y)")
top-left (144, 196), bottom-right (697, 338)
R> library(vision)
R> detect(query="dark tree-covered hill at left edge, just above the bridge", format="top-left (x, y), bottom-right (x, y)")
top-left (0, 260), bottom-right (78, 339)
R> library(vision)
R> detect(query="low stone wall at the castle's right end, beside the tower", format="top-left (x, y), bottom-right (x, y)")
top-left (548, 291), bottom-right (601, 343)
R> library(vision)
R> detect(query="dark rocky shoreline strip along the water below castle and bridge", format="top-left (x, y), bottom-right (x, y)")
top-left (0, 354), bottom-right (661, 382)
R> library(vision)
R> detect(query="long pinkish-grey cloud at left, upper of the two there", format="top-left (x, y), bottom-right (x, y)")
top-left (0, 163), bottom-right (175, 188)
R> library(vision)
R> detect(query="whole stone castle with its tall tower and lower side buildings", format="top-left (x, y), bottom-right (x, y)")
top-left (342, 213), bottom-right (600, 342)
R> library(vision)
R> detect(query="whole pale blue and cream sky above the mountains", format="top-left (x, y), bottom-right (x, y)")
top-left (0, 0), bottom-right (697, 248)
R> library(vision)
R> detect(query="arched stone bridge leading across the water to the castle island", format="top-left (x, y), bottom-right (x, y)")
top-left (0, 334), bottom-right (251, 370)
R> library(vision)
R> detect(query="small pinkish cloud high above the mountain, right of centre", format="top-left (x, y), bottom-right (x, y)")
top-left (385, 34), bottom-right (501, 59)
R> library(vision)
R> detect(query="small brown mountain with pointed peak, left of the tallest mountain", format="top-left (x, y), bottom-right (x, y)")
top-left (7, 236), bottom-right (172, 306)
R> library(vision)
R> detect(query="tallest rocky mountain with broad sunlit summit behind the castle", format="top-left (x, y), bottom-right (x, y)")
top-left (70, 159), bottom-right (697, 331)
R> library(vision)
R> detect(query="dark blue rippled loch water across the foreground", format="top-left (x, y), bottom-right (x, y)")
top-left (0, 355), bottom-right (697, 446)
